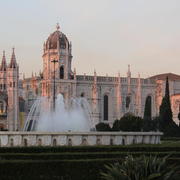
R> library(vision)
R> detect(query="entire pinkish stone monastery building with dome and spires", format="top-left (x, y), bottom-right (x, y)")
top-left (0, 26), bottom-right (180, 130)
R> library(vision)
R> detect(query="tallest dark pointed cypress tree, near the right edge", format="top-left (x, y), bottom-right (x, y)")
top-left (159, 77), bottom-right (173, 124)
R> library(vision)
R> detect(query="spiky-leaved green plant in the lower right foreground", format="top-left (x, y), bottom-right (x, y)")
top-left (101, 155), bottom-right (179, 180)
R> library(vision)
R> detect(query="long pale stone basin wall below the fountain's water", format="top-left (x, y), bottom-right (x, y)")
top-left (0, 131), bottom-right (163, 147)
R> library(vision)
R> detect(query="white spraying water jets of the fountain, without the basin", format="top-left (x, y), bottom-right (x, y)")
top-left (24, 94), bottom-right (95, 132)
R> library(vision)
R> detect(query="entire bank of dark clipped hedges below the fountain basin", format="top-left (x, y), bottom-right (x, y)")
top-left (0, 144), bottom-right (180, 180)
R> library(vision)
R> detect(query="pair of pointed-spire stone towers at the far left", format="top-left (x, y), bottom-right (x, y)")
top-left (0, 48), bottom-right (20, 131)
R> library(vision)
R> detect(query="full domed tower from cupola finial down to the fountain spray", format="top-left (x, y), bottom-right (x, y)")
top-left (42, 24), bottom-right (74, 98)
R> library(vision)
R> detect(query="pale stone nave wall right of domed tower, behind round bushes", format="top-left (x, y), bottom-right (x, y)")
top-left (75, 76), bottom-right (158, 125)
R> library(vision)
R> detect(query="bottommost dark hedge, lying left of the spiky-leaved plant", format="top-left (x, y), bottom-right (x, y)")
top-left (0, 158), bottom-right (180, 180)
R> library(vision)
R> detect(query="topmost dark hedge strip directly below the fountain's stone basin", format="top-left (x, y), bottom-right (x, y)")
top-left (0, 144), bottom-right (180, 153)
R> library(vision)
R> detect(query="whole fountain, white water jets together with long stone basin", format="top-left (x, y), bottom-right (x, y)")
top-left (0, 94), bottom-right (163, 147)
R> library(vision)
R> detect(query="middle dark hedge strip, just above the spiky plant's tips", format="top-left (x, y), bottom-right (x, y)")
top-left (0, 152), bottom-right (180, 160)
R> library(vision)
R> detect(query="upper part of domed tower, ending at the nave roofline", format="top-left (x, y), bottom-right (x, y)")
top-left (42, 24), bottom-right (72, 80)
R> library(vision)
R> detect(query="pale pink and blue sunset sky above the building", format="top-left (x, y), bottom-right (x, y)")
top-left (0, 0), bottom-right (180, 78)
